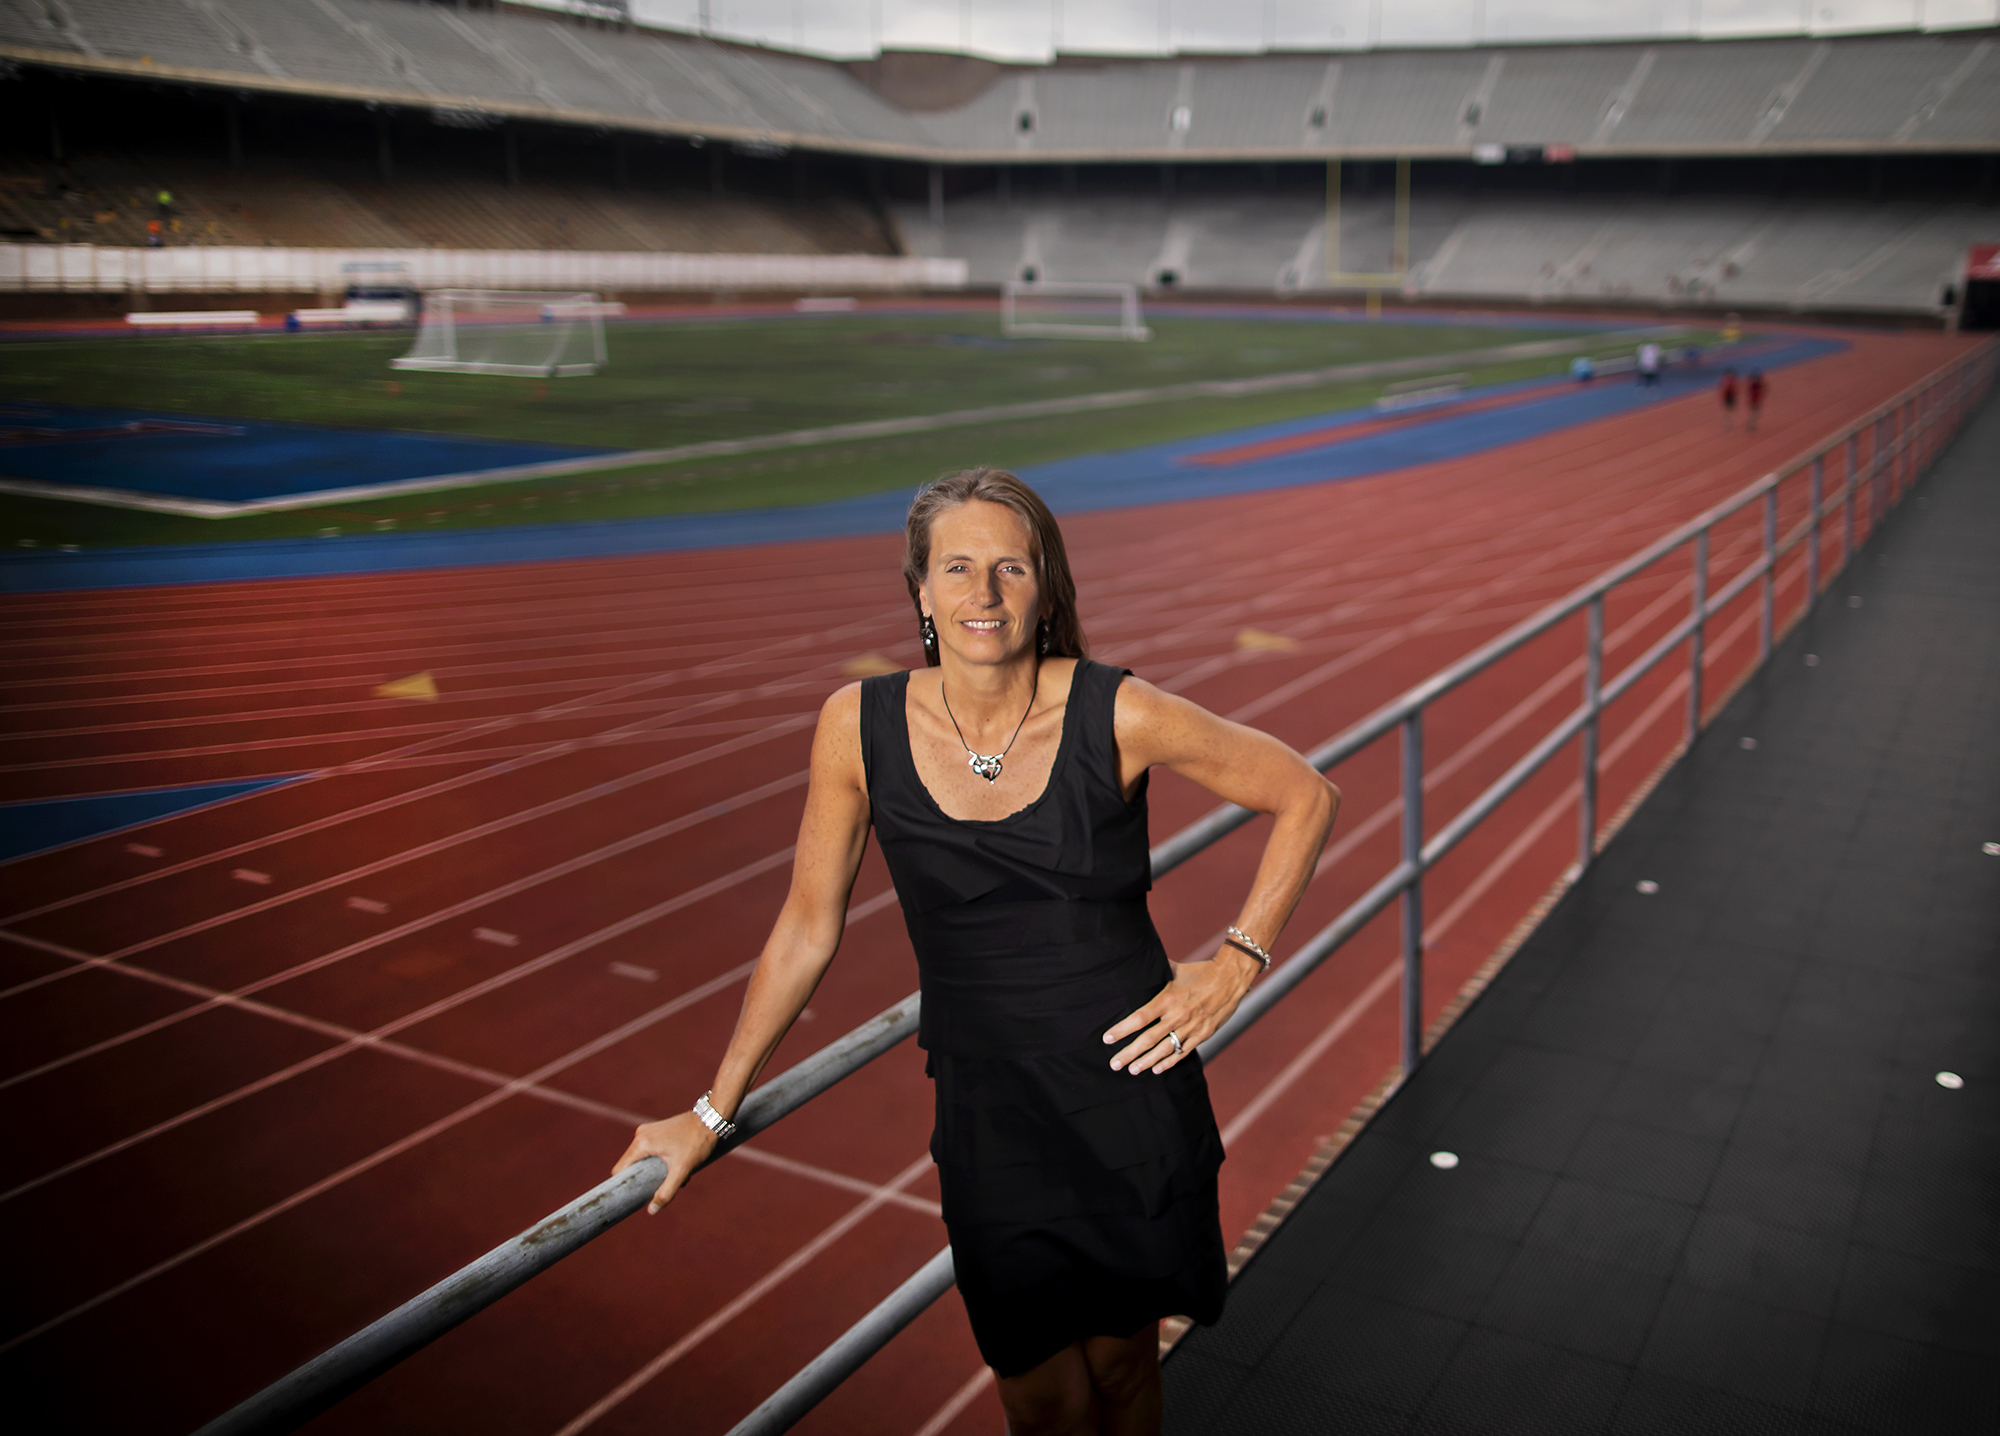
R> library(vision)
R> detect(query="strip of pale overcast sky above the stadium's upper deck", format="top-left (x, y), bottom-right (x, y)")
top-left (596, 0), bottom-right (2000, 60)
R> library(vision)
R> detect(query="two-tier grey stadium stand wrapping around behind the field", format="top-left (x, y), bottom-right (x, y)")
top-left (0, 0), bottom-right (2000, 316)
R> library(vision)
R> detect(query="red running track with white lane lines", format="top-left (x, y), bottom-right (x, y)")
top-left (0, 334), bottom-right (1966, 1436)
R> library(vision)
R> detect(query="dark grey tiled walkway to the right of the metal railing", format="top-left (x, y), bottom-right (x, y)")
top-left (1166, 394), bottom-right (2000, 1436)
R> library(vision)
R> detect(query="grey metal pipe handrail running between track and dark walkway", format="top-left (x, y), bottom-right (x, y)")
top-left (198, 344), bottom-right (1994, 1436)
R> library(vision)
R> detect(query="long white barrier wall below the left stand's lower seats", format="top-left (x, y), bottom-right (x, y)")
top-left (0, 244), bottom-right (966, 294)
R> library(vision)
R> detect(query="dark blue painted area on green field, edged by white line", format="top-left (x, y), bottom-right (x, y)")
top-left (0, 402), bottom-right (616, 504)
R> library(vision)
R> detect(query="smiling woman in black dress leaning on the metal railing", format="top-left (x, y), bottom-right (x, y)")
top-left (614, 468), bottom-right (1338, 1436)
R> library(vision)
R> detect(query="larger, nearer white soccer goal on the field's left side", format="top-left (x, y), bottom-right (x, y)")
top-left (390, 290), bottom-right (608, 378)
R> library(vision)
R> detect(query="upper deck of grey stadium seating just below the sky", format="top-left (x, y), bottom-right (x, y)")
top-left (0, 0), bottom-right (2000, 164)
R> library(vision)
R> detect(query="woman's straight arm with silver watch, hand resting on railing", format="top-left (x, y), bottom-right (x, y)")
top-left (612, 684), bottom-right (868, 1212)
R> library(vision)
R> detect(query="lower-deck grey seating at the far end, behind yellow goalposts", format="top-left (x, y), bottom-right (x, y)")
top-left (896, 192), bottom-right (1992, 310)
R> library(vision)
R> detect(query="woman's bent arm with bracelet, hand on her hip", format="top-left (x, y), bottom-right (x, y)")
top-left (1104, 678), bottom-right (1340, 1074)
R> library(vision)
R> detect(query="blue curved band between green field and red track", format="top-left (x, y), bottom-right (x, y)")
top-left (0, 336), bottom-right (1846, 592)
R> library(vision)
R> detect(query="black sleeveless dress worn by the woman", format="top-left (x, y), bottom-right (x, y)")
top-left (862, 658), bottom-right (1228, 1376)
